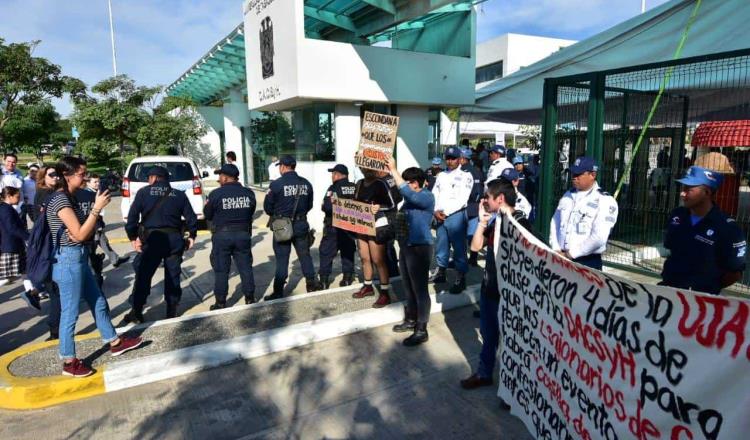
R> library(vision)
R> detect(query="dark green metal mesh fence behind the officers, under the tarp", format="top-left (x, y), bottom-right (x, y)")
top-left (537, 49), bottom-right (750, 295)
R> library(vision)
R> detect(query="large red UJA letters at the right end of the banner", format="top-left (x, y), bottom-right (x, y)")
top-left (677, 291), bottom-right (750, 359)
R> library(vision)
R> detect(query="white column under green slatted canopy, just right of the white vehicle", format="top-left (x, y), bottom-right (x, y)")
top-left (222, 90), bottom-right (252, 184)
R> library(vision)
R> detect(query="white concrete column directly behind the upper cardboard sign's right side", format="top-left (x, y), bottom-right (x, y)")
top-left (396, 105), bottom-right (430, 171)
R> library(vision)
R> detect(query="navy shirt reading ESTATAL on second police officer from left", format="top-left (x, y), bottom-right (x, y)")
top-left (203, 182), bottom-right (256, 232)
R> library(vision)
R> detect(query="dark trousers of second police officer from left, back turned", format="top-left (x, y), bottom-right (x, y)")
top-left (211, 231), bottom-right (255, 303)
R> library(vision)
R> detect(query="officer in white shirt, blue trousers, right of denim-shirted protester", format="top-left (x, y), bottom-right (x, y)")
top-left (430, 147), bottom-right (474, 294)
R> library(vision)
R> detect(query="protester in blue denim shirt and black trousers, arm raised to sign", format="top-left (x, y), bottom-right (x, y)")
top-left (388, 158), bottom-right (435, 347)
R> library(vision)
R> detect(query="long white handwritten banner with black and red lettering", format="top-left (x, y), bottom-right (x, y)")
top-left (495, 217), bottom-right (750, 440)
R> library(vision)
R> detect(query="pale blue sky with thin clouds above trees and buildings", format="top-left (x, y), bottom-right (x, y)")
top-left (0, 0), bottom-right (667, 116)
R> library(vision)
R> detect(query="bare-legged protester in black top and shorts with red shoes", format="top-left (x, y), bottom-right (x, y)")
top-left (352, 169), bottom-right (396, 308)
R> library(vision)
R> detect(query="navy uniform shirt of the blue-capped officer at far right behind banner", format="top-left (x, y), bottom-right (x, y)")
top-left (661, 206), bottom-right (747, 295)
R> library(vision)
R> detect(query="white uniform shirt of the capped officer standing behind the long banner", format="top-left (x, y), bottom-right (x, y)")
top-left (549, 183), bottom-right (617, 258)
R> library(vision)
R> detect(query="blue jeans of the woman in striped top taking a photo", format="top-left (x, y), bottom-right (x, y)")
top-left (52, 246), bottom-right (117, 359)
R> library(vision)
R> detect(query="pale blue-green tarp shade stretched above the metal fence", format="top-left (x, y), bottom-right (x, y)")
top-left (470, 0), bottom-right (750, 124)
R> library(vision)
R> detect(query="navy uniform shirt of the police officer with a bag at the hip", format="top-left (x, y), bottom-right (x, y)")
top-left (263, 171), bottom-right (313, 218)
